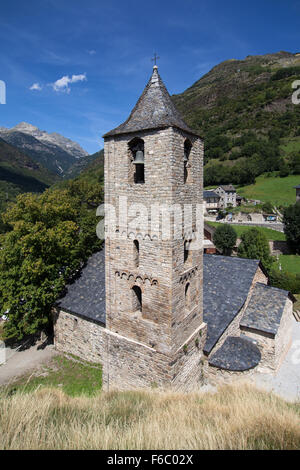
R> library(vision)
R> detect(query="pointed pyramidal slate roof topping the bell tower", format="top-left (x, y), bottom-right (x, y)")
top-left (103, 66), bottom-right (196, 137)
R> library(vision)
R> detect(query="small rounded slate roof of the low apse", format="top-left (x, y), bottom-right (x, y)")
top-left (208, 336), bottom-right (261, 371)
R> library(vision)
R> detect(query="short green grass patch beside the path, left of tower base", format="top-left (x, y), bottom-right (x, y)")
top-left (7, 355), bottom-right (102, 397)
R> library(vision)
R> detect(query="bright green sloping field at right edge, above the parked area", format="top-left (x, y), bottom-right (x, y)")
top-left (237, 175), bottom-right (300, 206)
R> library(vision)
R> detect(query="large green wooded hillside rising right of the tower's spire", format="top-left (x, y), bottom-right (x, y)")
top-left (172, 52), bottom-right (300, 185)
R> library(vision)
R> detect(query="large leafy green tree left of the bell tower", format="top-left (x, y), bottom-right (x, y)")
top-left (0, 182), bottom-right (101, 339)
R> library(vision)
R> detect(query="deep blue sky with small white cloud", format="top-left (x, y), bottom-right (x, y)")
top-left (0, 0), bottom-right (300, 153)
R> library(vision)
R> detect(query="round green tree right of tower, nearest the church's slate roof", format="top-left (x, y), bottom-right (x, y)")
top-left (238, 228), bottom-right (273, 270)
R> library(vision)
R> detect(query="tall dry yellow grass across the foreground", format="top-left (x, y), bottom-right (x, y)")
top-left (0, 385), bottom-right (300, 449)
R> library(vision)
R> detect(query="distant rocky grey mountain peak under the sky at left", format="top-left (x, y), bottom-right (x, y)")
top-left (0, 122), bottom-right (88, 177)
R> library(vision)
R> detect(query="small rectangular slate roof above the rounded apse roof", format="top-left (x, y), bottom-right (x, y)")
top-left (240, 282), bottom-right (290, 335)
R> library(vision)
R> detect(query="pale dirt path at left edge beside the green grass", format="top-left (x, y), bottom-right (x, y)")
top-left (0, 344), bottom-right (58, 386)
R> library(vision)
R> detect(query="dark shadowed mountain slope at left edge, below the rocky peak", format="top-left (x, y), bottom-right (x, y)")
top-left (0, 138), bottom-right (59, 216)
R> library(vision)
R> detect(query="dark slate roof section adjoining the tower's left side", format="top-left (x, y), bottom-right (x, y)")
top-left (56, 250), bottom-right (105, 324)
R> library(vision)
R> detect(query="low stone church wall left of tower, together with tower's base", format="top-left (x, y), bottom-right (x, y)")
top-left (54, 310), bottom-right (206, 390)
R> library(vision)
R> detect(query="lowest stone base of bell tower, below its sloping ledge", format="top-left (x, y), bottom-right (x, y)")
top-left (103, 324), bottom-right (206, 391)
